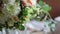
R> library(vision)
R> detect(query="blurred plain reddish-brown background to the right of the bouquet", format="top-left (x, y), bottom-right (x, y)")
top-left (43, 0), bottom-right (60, 34)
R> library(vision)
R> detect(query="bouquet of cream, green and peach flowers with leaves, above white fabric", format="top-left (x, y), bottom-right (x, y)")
top-left (0, 0), bottom-right (55, 30)
